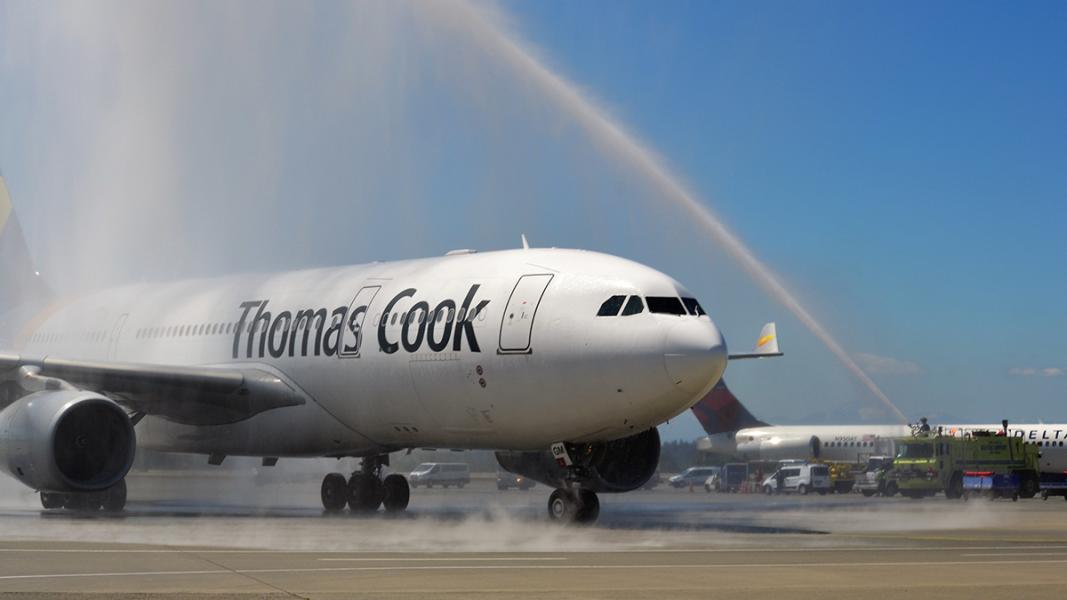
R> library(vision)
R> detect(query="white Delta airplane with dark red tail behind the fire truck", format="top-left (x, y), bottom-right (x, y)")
top-left (692, 379), bottom-right (1067, 475)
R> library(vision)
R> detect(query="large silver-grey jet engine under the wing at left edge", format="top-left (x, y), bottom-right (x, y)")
top-left (0, 391), bottom-right (137, 492)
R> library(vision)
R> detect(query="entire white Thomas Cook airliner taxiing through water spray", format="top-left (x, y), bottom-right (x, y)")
top-left (0, 179), bottom-right (778, 522)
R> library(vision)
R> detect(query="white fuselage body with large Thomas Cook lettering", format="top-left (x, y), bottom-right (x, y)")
top-left (16, 250), bottom-right (727, 456)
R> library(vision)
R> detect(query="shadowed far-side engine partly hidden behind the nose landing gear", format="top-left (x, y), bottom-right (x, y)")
top-left (496, 428), bottom-right (659, 493)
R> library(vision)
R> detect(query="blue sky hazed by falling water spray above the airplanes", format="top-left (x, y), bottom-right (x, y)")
top-left (0, 1), bottom-right (1067, 437)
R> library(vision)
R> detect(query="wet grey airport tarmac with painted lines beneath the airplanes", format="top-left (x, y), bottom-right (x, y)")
top-left (0, 473), bottom-right (1067, 599)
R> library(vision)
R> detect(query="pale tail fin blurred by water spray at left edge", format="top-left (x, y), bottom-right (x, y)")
top-left (0, 176), bottom-right (48, 315)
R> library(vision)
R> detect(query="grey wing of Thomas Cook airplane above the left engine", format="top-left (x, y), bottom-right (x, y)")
top-left (0, 354), bottom-right (305, 425)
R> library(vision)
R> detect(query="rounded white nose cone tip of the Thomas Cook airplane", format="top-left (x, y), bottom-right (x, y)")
top-left (664, 321), bottom-right (727, 394)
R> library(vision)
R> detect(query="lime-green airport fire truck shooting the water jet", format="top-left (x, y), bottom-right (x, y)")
top-left (886, 431), bottom-right (1040, 499)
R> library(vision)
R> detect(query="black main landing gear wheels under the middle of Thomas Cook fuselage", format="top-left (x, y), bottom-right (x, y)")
top-left (322, 455), bottom-right (411, 515)
